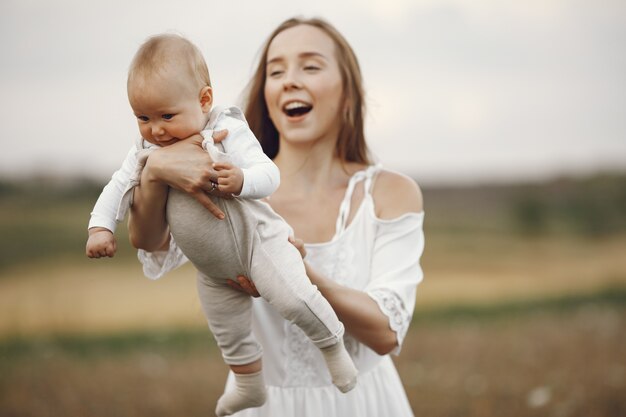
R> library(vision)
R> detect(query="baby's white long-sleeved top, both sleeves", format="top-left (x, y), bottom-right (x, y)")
top-left (88, 106), bottom-right (280, 232)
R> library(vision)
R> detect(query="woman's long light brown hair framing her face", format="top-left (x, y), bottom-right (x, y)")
top-left (245, 18), bottom-right (371, 164)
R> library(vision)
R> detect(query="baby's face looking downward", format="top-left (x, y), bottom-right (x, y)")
top-left (128, 74), bottom-right (210, 146)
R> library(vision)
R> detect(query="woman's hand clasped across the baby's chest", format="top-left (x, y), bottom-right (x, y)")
top-left (145, 130), bottom-right (232, 219)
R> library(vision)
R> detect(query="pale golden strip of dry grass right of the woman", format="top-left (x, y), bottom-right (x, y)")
top-left (417, 234), bottom-right (626, 309)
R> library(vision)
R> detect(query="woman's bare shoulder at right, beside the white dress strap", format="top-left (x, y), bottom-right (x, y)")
top-left (372, 170), bottom-right (424, 220)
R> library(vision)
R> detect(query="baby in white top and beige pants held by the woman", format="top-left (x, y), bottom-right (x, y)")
top-left (87, 34), bottom-right (357, 416)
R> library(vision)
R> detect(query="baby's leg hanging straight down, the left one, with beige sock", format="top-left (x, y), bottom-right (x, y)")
top-left (198, 272), bottom-right (266, 417)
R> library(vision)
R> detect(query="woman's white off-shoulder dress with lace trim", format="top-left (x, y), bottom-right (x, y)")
top-left (226, 166), bottom-right (424, 417)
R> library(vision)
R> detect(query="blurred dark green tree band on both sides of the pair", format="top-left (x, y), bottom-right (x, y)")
top-left (0, 173), bottom-right (626, 272)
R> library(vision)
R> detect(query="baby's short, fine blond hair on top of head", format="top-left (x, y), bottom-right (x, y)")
top-left (127, 33), bottom-right (211, 92)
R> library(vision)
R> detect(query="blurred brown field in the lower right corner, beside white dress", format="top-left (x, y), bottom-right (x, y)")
top-left (397, 305), bottom-right (626, 417)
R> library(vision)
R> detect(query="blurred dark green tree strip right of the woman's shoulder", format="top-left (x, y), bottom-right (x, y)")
top-left (423, 173), bottom-right (626, 238)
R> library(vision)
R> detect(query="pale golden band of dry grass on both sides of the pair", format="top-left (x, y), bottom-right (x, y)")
top-left (0, 235), bottom-right (626, 339)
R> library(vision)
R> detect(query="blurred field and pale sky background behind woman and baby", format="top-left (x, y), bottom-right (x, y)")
top-left (0, 0), bottom-right (626, 417)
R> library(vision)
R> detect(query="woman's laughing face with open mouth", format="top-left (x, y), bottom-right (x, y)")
top-left (264, 25), bottom-right (345, 148)
